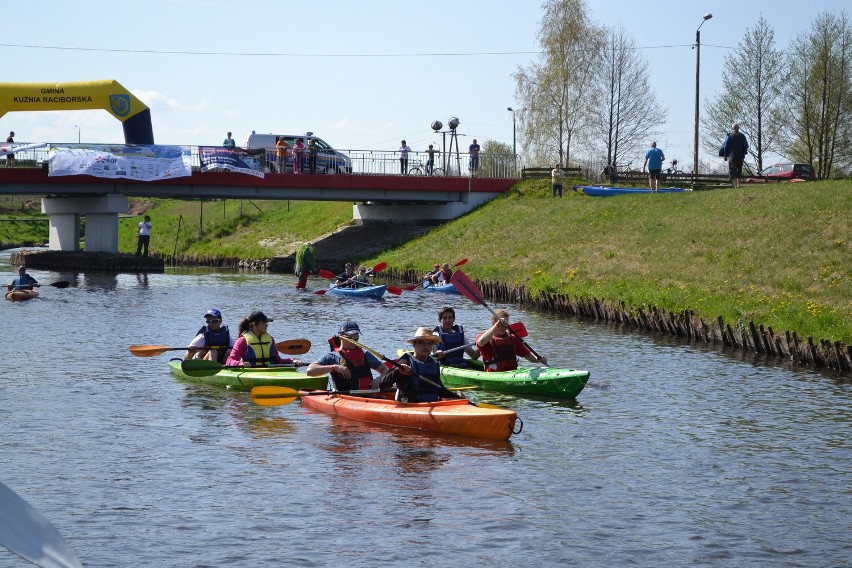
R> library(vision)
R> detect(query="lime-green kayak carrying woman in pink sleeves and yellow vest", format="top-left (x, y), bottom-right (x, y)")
top-left (169, 359), bottom-right (328, 390)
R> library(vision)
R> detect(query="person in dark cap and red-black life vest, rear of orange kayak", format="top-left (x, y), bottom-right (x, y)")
top-left (305, 320), bottom-right (388, 391)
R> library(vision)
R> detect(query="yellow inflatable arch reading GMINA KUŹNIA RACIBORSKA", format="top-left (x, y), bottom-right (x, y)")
top-left (0, 79), bottom-right (154, 144)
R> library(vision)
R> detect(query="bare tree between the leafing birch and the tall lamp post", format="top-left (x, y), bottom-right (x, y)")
top-left (596, 26), bottom-right (668, 177)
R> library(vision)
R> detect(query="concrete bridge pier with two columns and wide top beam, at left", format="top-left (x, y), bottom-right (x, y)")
top-left (41, 195), bottom-right (128, 252)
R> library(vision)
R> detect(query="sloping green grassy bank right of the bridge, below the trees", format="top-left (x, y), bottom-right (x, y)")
top-left (373, 180), bottom-right (852, 344)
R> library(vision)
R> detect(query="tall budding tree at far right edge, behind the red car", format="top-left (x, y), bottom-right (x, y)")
top-left (783, 12), bottom-right (852, 178)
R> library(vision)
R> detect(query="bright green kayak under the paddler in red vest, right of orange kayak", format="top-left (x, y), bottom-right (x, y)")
top-left (441, 361), bottom-right (589, 398)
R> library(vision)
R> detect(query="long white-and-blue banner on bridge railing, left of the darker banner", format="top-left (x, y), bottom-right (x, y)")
top-left (47, 144), bottom-right (192, 181)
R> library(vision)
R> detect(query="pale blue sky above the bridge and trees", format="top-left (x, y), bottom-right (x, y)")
top-left (0, 0), bottom-right (852, 163)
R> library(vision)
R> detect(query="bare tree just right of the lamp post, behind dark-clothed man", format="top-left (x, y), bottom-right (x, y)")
top-left (702, 16), bottom-right (786, 171)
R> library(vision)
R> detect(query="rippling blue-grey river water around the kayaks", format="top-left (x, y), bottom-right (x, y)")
top-left (0, 252), bottom-right (852, 568)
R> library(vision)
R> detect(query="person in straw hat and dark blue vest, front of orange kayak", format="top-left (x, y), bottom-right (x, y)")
top-left (387, 327), bottom-right (445, 402)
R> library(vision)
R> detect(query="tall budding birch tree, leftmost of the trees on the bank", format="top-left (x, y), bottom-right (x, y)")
top-left (513, 0), bottom-right (603, 165)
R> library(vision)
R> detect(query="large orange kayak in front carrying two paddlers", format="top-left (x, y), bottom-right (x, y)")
top-left (300, 391), bottom-right (518, 440)
